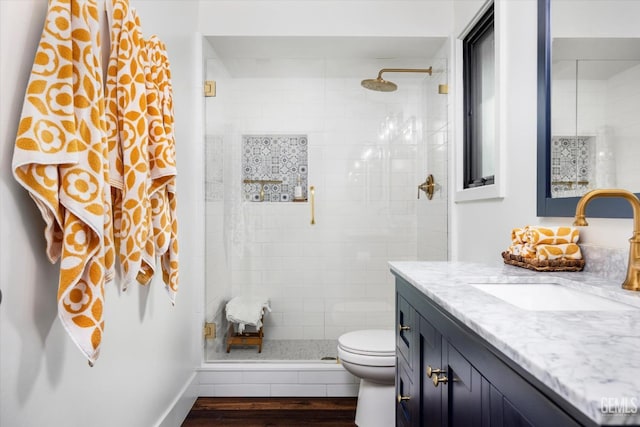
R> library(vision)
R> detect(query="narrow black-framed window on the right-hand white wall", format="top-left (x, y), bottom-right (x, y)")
top-left (462, 5), bottom-right (496, 188)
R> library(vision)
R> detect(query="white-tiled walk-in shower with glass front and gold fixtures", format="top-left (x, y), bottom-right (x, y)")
top-left (204, 37), bottom-right (448, 363)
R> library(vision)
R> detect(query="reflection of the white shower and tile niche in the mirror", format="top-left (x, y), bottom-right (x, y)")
top-left (551, 37), bottom-right (640, 197)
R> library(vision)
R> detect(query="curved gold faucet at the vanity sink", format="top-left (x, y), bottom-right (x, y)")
top-left (573, 189), bottom-right (640, 291)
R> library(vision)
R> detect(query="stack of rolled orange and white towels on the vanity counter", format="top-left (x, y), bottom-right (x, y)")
top-left (508, 225), bottom-right (582, 261)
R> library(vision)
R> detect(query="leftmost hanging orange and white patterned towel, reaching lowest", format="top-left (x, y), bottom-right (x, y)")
top-left (12, 0), bottom-right (113, 364)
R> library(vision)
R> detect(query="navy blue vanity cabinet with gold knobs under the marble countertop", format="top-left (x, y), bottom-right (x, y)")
top-left (396, 277), bottom-right (594, 427)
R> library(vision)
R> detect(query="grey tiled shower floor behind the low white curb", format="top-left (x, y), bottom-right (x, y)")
top-left (206, 339), bottom-right (338, 363)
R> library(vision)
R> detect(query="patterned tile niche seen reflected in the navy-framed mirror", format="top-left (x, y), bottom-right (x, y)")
top-left (551, 136), bottom-right (593, 197)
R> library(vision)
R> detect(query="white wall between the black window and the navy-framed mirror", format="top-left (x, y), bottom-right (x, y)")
top-left (451, 0), bottom-right (632, 263)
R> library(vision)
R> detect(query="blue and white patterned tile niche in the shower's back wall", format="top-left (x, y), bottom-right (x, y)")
top-left (242, 135), bottom-right (308, 202)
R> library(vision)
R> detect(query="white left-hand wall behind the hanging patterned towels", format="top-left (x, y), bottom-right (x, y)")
top-left (0, 0), bottom-right (203, 427)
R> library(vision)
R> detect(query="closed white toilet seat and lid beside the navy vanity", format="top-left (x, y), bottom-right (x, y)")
top-left (338, 329), bottom-right (396, 366)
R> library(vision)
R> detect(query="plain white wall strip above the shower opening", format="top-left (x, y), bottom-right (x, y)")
top-left (199, 0), bottom-right (452, 37)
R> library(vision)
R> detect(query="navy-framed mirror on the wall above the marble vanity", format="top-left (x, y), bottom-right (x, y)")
top-left (537, 0), bottom-right (640, 218)
